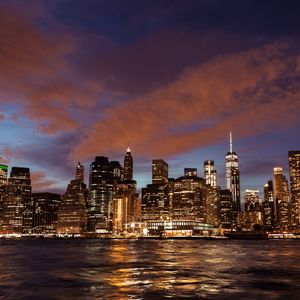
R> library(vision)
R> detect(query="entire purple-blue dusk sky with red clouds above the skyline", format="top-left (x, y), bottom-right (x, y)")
top-left (0, 0), bottom-right (300, 199)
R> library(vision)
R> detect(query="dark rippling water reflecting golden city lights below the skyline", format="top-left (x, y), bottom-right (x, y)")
top-left (0, 239), bottom-right (300, 299)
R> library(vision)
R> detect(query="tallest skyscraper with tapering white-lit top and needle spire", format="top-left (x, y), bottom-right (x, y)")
top-left (225, 132), bottom-right (241, 222)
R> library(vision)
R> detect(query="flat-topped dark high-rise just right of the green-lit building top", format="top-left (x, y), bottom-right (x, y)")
top-left (0, 167), bottom-right (31, 233)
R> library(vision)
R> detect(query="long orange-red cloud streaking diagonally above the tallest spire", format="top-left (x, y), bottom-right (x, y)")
top-left (72, 43), bottom-right (300, 159)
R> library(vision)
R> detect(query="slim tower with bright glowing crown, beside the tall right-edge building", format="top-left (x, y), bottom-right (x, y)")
top-left (274, 167), bottom-right (290, 227)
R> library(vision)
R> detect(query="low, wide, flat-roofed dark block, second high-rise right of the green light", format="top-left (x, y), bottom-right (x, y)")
top-left (23, 193), bottom-right (61, 234)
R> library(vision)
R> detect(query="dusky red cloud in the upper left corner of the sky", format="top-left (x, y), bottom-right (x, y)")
top-left (0, 5), bottom-right (101, 134)
